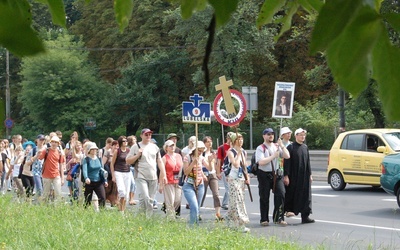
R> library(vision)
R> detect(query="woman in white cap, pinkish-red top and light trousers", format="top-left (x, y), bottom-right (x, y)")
top-left (159, 140), bottom-right (183, 218)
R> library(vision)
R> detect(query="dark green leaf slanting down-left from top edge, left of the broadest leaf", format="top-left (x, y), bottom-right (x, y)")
top-left (310, 0), bottom-right (362, 54)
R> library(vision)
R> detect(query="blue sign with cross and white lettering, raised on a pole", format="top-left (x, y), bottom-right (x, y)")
top-left (182, 94), bottom-right (211, 124)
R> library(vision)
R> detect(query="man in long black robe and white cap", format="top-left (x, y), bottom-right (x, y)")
top-left (283, 128), bottom-right (315, 223)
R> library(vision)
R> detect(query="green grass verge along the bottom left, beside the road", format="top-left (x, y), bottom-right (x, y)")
top-left (0, 195), bottom-right (304, 250)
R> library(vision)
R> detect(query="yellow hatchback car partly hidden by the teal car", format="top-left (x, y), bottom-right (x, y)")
top-left (328, 129), bottom-right (400, 191)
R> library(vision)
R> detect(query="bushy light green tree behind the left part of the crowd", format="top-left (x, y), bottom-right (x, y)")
top-left (19, 34), bottom-right (109, 134)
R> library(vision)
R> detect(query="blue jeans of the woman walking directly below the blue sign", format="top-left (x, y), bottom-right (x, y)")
top-left (182, 182), bottom-right (204, 225)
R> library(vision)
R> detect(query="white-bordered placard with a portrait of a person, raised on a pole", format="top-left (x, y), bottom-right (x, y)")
top-left (272, 82), bottom-right (295, 118)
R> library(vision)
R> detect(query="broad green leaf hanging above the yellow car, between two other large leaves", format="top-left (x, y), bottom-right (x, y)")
top-left (327, 6), bottom-right (382, 95)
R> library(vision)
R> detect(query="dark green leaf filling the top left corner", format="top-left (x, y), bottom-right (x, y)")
top-left (0, 0), bottom-right (44, 56)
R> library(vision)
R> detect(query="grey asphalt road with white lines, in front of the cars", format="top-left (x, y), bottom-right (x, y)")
top-left (188, 178), bottom-right (400, 249)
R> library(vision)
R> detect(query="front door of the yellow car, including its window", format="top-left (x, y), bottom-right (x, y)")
top-left (362, 134), bottom-right (385, 185)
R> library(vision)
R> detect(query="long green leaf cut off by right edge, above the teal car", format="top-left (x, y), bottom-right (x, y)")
top-left (372, 24), bottom-right (400, 121)
